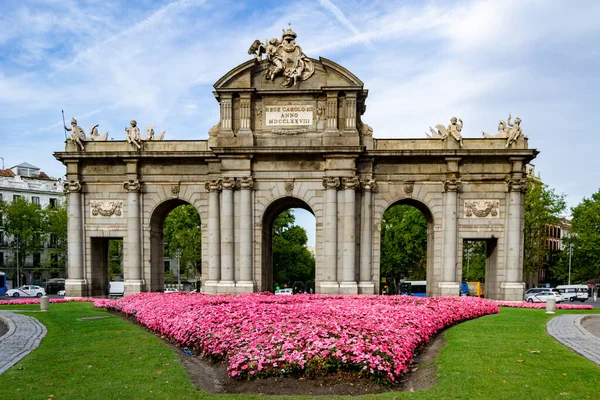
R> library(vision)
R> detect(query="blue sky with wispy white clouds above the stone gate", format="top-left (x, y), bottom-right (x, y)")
top-left (0, 0), bottom-right (600, 247)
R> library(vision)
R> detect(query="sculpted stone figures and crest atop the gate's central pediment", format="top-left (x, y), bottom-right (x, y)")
top-left (248, 26), bottom-right (315, 88)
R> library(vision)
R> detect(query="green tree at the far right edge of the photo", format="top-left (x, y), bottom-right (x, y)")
top-left (552, 190), bottom-right (600, 283)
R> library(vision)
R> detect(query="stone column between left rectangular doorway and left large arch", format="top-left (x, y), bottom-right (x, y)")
top-left (123, 179), bottom-right (144, 294)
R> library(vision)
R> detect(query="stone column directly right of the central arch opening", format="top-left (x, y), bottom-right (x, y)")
top-left (321, 177), bottom-right (340, 294)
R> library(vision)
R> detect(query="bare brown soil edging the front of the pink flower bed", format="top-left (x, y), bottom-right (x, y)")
top-left (113, 312), bottom-right (444, 396)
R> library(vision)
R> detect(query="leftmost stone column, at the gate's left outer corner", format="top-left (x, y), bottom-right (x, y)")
top-left (63, 180), bottom-right (87, 297)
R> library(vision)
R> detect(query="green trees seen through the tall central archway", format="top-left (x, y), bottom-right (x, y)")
top-left (272, 210), bottom-right (315, 285)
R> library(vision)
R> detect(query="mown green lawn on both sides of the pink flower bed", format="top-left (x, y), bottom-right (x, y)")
top-left (0, 303), bottom-right (600, 400)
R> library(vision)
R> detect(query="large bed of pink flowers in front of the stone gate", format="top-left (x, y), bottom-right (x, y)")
top-left (94, 293), bottom-right (499, 382)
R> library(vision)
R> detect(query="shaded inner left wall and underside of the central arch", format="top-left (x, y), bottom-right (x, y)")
top-left (260, 196), bottom-right (318, 290)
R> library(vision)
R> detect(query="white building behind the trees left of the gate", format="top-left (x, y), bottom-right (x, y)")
top-left (0, 163), bottom-right (65, 284)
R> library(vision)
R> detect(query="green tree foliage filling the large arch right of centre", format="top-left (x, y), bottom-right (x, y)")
top-left (381, 204), bottom-right (427, 282)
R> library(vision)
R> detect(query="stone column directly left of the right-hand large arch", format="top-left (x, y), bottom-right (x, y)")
top-left (358, 179), bottom-right (375, 294)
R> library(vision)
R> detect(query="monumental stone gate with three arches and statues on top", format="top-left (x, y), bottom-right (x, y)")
top-left (56, 29), bottom-right (537, 300)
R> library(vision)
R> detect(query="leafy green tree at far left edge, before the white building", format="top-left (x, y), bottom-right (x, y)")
top-left (0, 197), bottom-right (45, 284)
